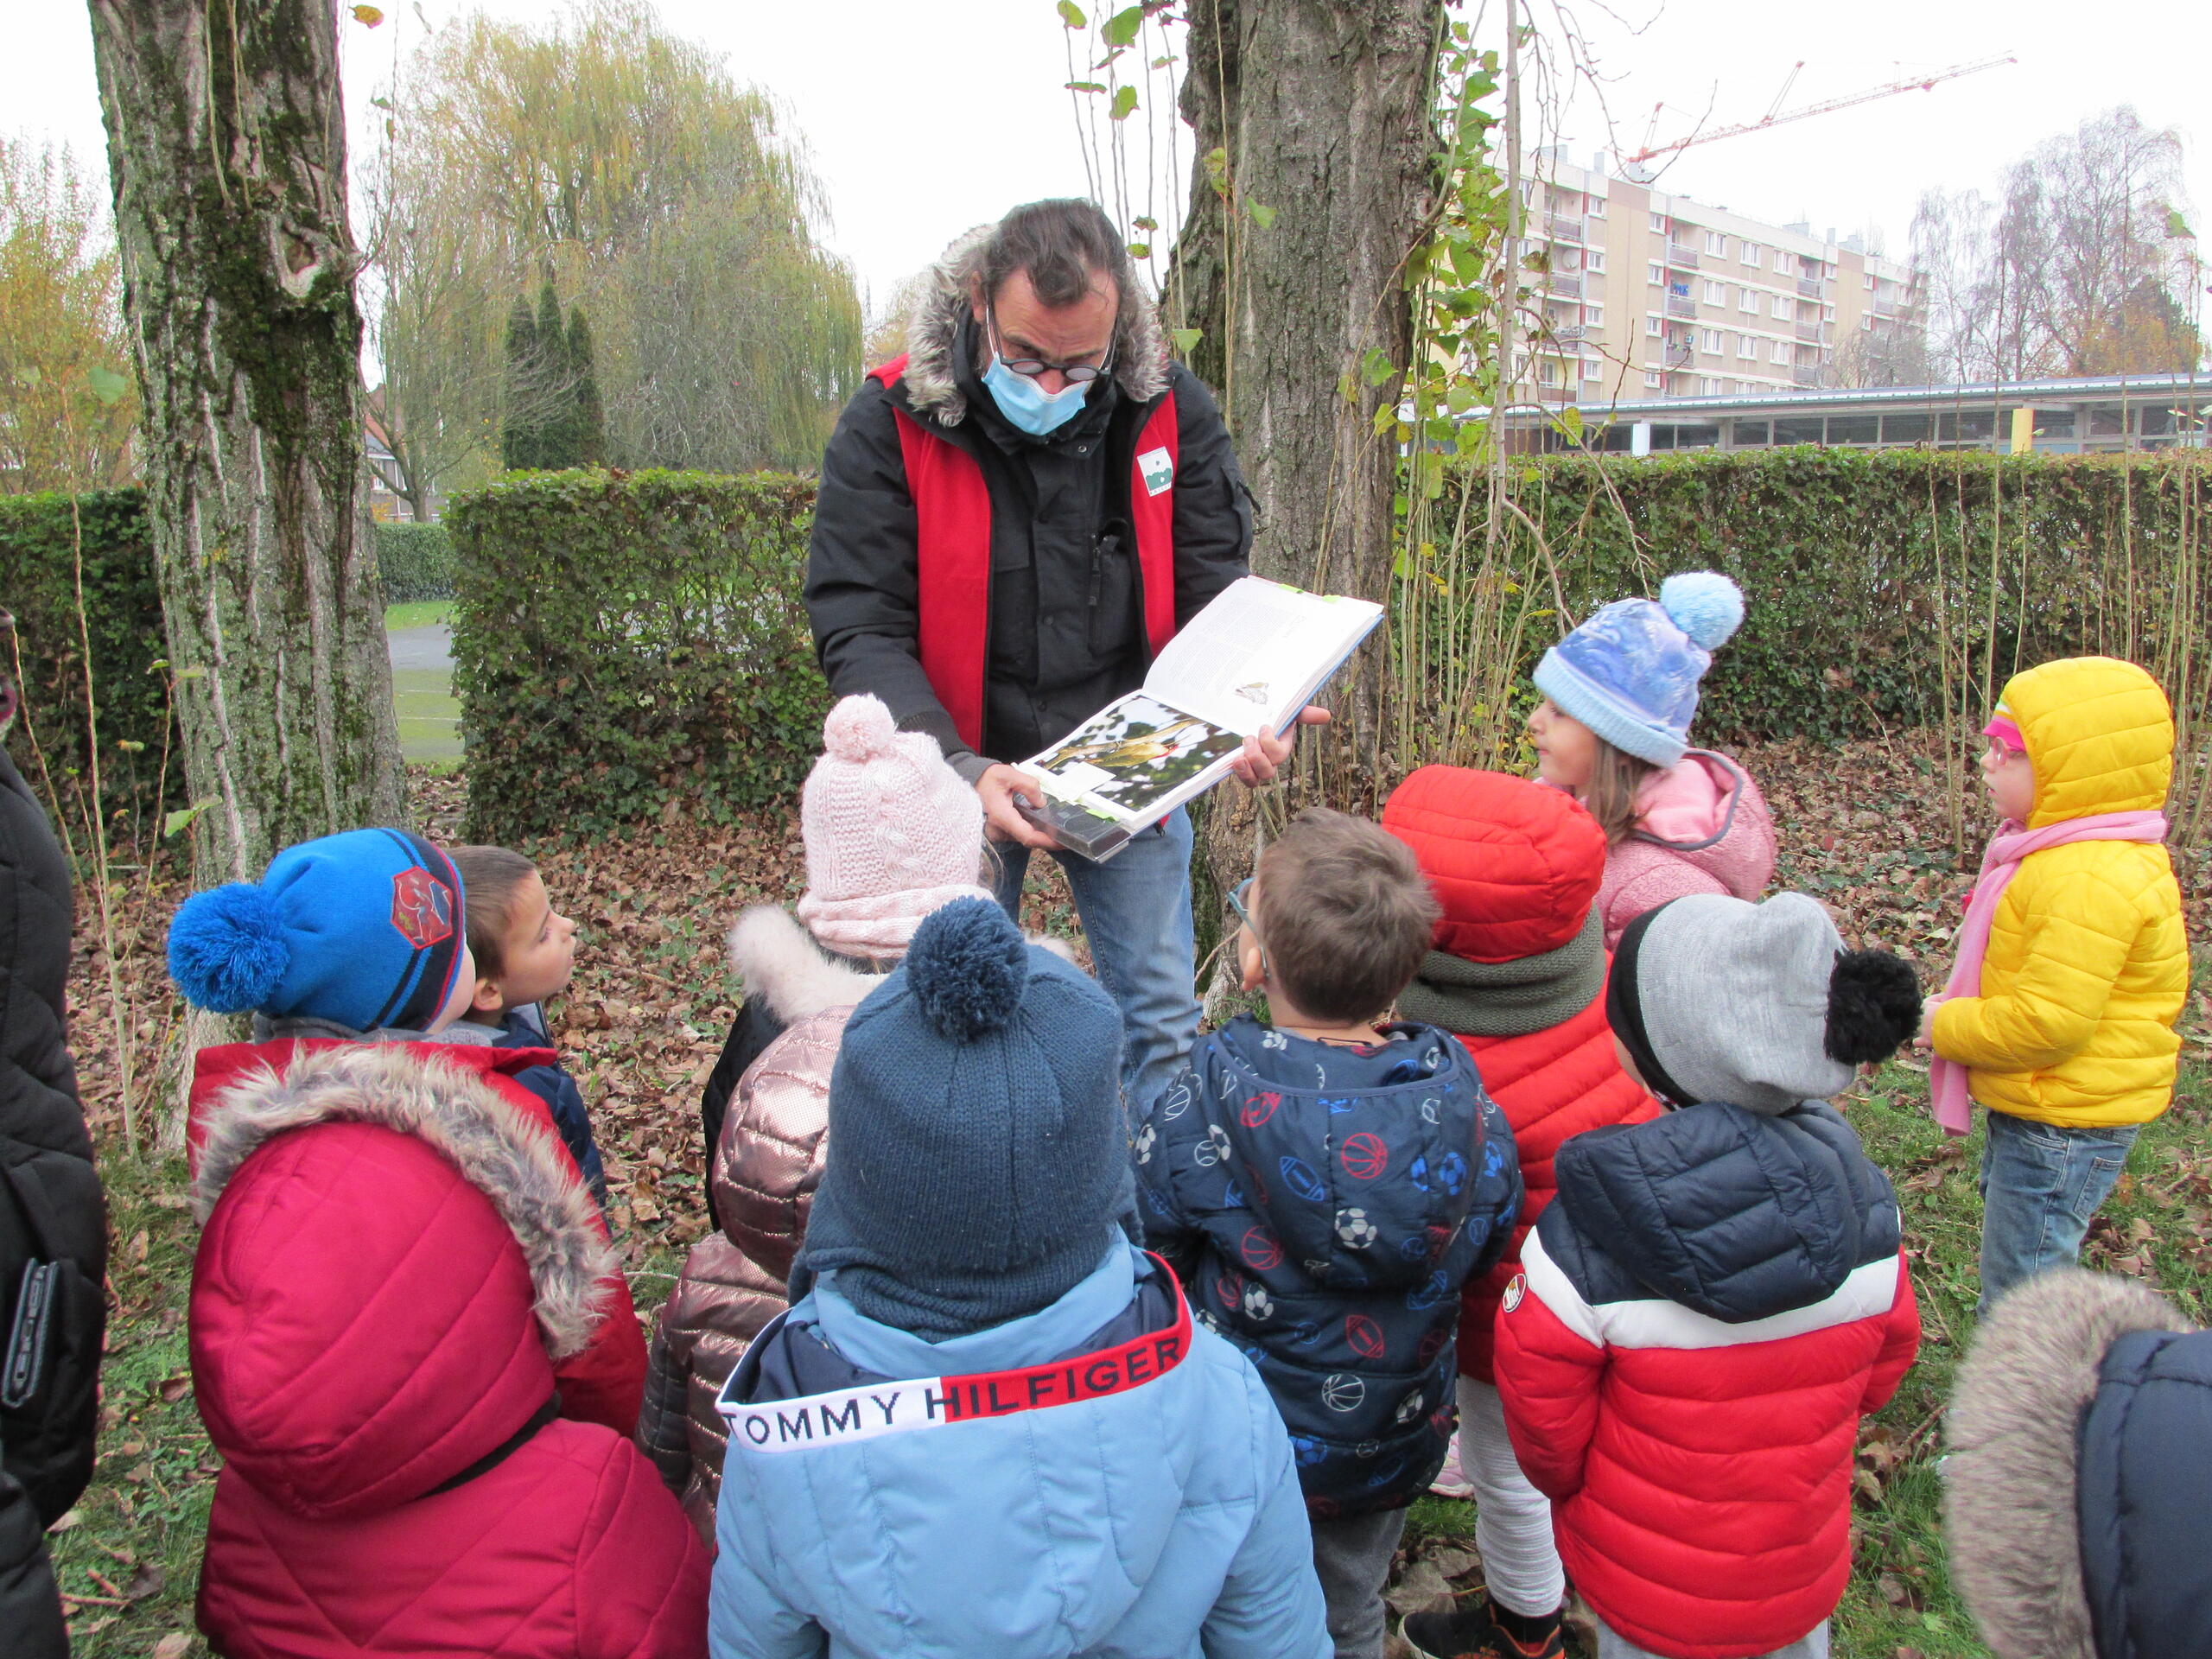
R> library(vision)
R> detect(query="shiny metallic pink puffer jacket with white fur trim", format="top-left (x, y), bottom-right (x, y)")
top-left (637, 907), bottom-right (878, 1546)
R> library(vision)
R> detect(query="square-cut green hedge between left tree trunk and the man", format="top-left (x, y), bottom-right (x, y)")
top-left (445, 469), bottom-right (827, 841)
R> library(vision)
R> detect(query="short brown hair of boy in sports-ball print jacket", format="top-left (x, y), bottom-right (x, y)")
top-left (1252, 807), bottom-right (1438, 1024)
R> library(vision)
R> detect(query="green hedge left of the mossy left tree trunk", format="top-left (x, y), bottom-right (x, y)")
top-left (0, 489), bottom-right (183, 842)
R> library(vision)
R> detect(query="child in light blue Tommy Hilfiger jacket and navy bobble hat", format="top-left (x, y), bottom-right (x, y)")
top-left (710, 898), bottom-right (1330, 1659)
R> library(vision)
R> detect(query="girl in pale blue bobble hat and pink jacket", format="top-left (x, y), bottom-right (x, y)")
top-left (1529, 570), bottom-right (1774, 951)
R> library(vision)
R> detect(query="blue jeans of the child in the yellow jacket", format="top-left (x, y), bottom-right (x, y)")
top-left (1975, 1113), bottom-right (2139, 1316)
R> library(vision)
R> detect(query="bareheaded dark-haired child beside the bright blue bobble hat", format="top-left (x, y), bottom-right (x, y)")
top-left (449, 847), bottom-right (606, 1210)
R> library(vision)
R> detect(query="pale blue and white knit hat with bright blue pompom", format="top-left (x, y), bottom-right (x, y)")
top-left (1535, 570), bottom-right (1743, 766)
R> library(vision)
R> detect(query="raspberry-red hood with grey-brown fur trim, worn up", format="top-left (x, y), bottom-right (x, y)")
top-left (193, 1044), bottom-right (620, 1520)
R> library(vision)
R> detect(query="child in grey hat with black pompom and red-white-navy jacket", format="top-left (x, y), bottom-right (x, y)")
top-left (1496, 893), bottom-right (1920, 1659)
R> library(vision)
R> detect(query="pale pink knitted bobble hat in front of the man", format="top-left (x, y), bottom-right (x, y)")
top-left (798, 695), bottom-right (991, 963)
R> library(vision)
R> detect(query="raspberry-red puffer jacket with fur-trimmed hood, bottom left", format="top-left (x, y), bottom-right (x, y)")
top-left (193, 1044), bottom-right (710, 1659)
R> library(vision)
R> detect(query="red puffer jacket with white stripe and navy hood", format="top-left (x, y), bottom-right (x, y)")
top-left (1496, 1102), bottom-right (1920, 1659)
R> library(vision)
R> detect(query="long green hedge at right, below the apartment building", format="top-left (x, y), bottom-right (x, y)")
top-left (1431, 447), bottom-right (2212, 741)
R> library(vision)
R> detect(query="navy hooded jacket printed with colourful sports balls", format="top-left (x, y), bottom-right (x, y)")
top-left (1135, 1018), bottom-right (1522, 1517)
